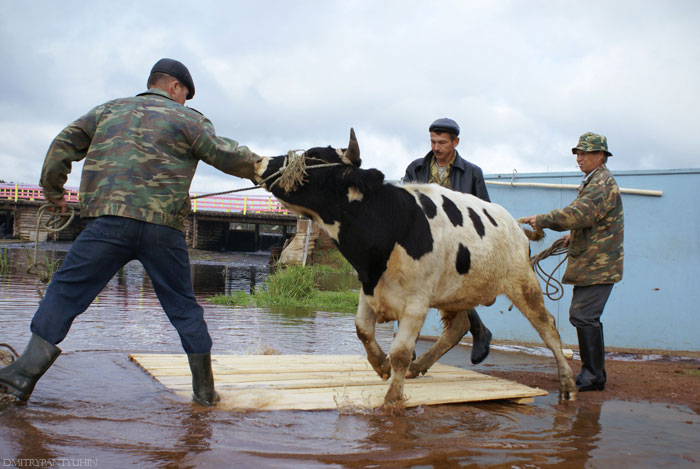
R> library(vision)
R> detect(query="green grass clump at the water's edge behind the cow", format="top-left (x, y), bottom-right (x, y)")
top-left (209, 266), bottom-right (359, 313)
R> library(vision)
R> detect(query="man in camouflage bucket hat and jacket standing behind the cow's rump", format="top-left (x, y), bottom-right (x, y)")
top-left (524, 132), bottom-right (624, 391)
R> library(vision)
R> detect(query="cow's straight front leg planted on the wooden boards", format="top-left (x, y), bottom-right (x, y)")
top-left (384, 314), bottom-right (425, 409)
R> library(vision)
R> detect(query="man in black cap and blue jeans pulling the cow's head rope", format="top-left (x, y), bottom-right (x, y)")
top-left (0, 58), bottom-right (258, 405)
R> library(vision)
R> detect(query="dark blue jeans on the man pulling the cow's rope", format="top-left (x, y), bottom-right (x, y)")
top-left (31, 216), bottom-right (211, 354)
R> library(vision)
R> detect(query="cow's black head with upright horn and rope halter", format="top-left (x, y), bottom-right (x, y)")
top-left (255, 129), bottom-right (384, 223)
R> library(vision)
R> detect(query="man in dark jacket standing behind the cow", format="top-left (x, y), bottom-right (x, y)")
top-left (403, 117), bottom-right (491, 364)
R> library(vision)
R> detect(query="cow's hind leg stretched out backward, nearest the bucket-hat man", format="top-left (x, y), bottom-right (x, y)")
top-left (508, 272), bottom-right (576, 401)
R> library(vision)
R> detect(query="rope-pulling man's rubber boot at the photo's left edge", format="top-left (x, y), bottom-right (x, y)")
top-left (0, 334), bottom-right (61, 401)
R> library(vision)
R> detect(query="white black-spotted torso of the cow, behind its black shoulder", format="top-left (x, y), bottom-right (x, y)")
top-left (379, 184), bottom-right (529, 309)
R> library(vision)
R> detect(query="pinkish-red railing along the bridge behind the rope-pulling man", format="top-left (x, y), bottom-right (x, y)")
top-left (0, 183), bottom-right (289, 215)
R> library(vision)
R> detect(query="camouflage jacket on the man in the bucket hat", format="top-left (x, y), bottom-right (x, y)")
top-left (537, 165), bottom-right (624, 286)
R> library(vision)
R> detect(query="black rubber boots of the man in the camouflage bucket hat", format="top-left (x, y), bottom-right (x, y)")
top-left (576, 326), bottom-right (606, 392)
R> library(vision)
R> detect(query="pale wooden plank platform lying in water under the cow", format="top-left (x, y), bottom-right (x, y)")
top-left (129, 354), bottom-right (547, 410)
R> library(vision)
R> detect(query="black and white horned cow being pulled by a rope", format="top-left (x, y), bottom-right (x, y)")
top-left (255, 130), bottom-right (576, 406)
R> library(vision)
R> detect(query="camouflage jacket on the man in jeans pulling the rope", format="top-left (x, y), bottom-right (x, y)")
top-left (39, 88), bottom-right (257, 230)
